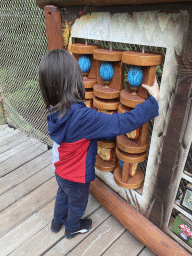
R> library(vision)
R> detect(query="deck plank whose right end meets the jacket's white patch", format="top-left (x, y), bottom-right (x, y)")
top-left (0, 150), bottom-right (52, 194)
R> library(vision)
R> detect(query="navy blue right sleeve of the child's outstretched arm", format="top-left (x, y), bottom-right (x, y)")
top-left (68, 96), bottom-right (159, 140)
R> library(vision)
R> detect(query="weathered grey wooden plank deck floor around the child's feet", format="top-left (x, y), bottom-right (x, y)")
top-left (0, 125), bottom-right (154, 256)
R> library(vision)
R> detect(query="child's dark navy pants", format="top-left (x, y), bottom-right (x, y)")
top-left (54, 174), bottom-right (90, 231)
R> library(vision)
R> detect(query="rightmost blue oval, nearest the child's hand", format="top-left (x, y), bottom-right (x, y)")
top-left (127, 66), bottom-right (143, 87)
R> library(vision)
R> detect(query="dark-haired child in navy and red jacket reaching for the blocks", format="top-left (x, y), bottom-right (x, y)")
top-left (39, 49), bottom-right (159, 239)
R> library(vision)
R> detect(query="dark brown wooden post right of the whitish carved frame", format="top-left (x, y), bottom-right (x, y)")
top-left (149, 9), bottom-right (192, 227)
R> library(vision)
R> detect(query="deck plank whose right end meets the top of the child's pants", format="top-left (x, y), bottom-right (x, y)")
top-left (0, 178), bottom-right (58, 236)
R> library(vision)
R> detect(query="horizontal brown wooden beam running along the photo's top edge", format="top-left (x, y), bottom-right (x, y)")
top-left (36, 0), bottom-right (189, 9)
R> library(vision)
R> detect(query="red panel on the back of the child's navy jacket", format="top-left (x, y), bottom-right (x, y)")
top-left (55, 139), bottom-right (90, 183)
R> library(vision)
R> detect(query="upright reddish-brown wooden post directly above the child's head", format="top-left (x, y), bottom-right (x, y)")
top-left (45, 5), bottom-right (63, 51)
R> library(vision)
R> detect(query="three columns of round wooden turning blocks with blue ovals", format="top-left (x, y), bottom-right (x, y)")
top-left (71, 40), bottom-right (163, 189)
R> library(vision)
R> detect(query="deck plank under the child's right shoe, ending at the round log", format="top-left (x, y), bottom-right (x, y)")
top-left (43, 207), bottom-right (110, 256)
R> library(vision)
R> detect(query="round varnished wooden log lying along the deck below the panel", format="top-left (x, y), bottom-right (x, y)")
top-left (90, 178), bottom-right (191, 256)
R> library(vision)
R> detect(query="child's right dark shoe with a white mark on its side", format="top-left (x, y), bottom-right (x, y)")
top-left (65, 219), bottom-right (92, 239)
